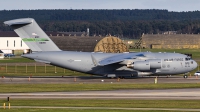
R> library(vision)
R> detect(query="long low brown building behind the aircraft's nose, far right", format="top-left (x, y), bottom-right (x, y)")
top-left (142, 34), bottom-right (200, 48)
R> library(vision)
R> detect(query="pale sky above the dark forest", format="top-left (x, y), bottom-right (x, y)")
top-left (0, 0), bottom-right (200, 11)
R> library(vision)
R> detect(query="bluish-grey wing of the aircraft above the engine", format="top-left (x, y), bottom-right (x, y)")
top-left (98, 53), bottom-right (145, 66)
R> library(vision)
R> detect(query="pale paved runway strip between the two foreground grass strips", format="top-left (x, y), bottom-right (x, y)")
top-left (0, 88), bottom-right (200, 100)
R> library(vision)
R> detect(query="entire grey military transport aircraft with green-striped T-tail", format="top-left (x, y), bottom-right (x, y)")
top-left (4, 18), bottom-right (197, 78)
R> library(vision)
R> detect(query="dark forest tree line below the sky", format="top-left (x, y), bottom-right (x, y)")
top-left (0, 9), bottom-right (200, 38)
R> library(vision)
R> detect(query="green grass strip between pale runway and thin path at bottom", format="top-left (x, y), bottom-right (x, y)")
top-left (0, 99), bottom-right (200, 109)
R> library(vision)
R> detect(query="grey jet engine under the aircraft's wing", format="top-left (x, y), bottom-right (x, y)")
top-left (127, 59), bottom-right (161, 71)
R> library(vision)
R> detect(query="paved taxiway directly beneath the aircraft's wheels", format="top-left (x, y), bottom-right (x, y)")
top-left (0, 76), bottom-right (200, 84)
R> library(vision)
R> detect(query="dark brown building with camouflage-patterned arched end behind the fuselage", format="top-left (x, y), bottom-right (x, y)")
top-left (50, 36), bottom-right (128, 53)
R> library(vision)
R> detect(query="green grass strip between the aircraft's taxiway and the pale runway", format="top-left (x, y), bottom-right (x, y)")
top-left (0, 82), bottom-right (200, 93)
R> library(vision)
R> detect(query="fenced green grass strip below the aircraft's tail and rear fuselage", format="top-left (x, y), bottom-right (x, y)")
top-left (0, 65), bottom-right (89, 77)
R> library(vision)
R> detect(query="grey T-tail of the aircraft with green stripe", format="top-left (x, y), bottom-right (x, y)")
top-left (4, 18), bottom-right (60, 52)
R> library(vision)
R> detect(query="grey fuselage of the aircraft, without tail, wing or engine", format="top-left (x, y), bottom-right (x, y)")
top-left (22, 51), bottom-right (197, 76)
